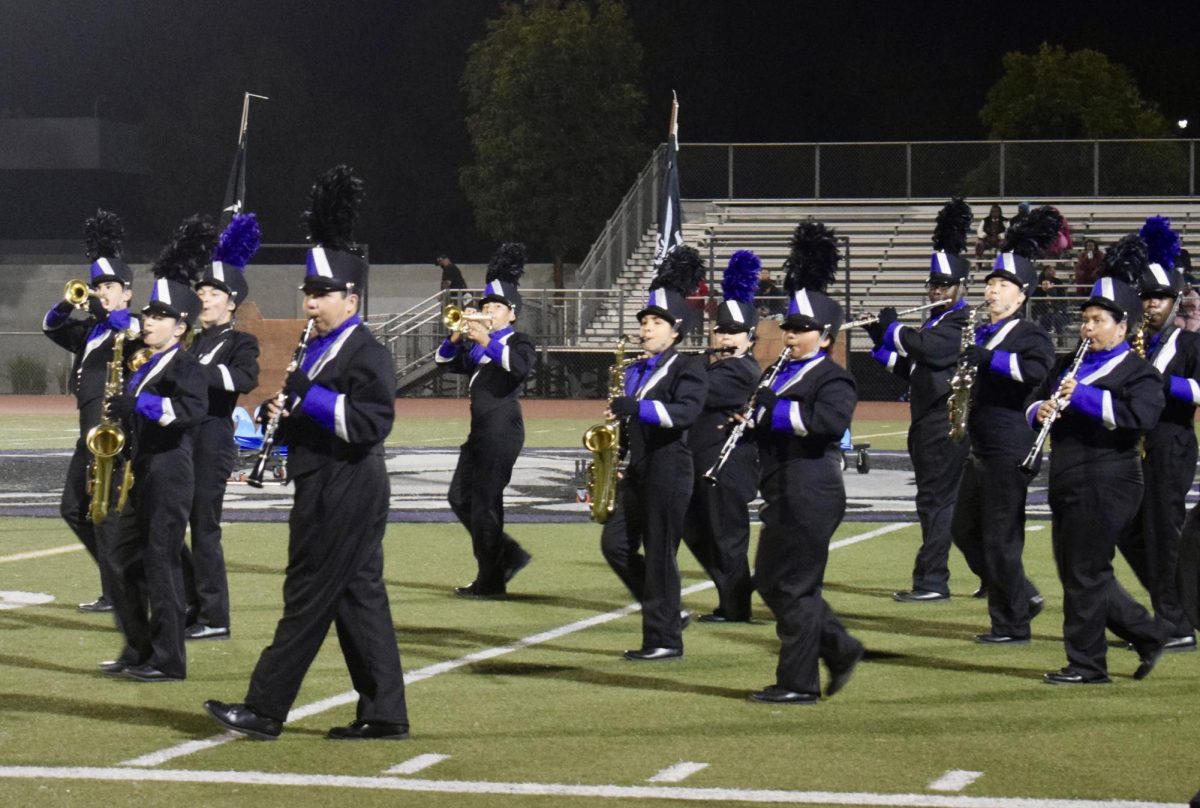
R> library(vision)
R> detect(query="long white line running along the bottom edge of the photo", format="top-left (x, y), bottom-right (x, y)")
top-left (0, 766), bottom-right (1182, 808)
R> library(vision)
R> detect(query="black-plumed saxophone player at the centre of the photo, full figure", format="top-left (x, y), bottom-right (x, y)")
top-left (600, 246), bottom-right (708, 662)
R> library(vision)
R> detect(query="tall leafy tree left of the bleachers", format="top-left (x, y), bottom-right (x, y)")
top-left (461, 0), bottom-right (649, 288)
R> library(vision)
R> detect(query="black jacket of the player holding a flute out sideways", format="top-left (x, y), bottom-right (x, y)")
top-left (872, 301), bottom-right (971, 420)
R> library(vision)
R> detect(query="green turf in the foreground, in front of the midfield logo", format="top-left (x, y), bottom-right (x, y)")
top-left (0, 519), bottom-right (1200, 808)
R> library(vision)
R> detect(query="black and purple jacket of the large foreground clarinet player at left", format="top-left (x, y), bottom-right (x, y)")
top-left (280, 321), bottom-right (396, 477)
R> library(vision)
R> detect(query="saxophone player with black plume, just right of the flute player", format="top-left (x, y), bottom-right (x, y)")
top-left (950, 208), bottom-right (1061, 644)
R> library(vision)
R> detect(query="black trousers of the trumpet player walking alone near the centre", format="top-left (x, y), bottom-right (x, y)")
top-left (448, 401), bottom-right (524, 592)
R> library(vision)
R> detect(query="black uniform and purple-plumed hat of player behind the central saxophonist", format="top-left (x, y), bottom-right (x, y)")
top-left (683, 250), bottom-right (762, 623)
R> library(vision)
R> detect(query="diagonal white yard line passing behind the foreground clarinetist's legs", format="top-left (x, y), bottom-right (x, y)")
top-left (119, 522), bottom-right (910, 767)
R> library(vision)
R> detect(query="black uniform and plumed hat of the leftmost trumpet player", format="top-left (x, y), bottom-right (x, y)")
top-left (42, 210), bottom-right (140, 611)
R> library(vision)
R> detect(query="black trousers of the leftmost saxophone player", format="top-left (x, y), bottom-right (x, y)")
top-left (108, 438), bottom-right (193, 677)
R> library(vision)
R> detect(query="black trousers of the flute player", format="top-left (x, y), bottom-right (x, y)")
top-left (908, 407), bottom-right (986, 594)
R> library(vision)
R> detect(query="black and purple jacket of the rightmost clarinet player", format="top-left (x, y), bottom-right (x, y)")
top-left (1025, 343), bottom-right (1163, 474)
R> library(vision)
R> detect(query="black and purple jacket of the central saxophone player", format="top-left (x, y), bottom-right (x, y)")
top-left (623, 348), bottom-right (708, 474)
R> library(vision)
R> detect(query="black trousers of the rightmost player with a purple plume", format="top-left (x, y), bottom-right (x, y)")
top-left (1118, 423), bottom-right (1196, 638)
